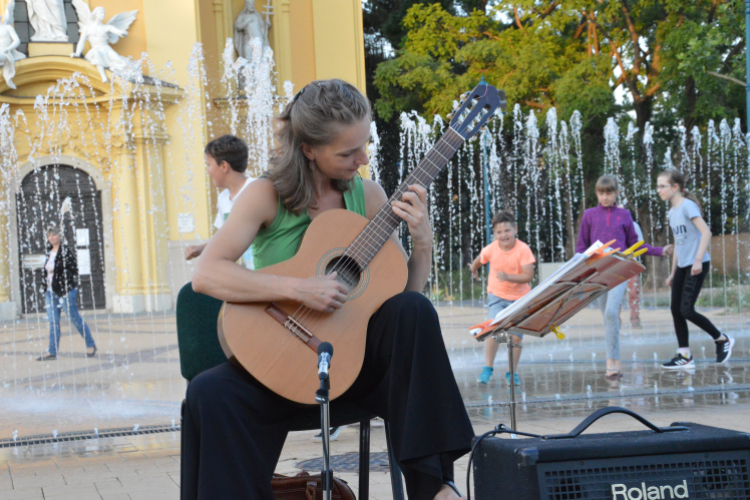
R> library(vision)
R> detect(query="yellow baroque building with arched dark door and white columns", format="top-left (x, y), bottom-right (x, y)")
top-left (0, 0), bottom-right (365, 320)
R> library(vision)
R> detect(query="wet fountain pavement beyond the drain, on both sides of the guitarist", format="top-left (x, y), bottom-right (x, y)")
top-left (0, 305), bottom-right (750, 440)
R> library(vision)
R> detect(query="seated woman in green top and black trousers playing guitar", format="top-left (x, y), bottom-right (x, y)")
top-left (182, 80), bottom-right (474, 500)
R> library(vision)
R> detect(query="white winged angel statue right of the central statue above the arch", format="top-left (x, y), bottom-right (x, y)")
top-left (70, 0), bottom-right (138, 82)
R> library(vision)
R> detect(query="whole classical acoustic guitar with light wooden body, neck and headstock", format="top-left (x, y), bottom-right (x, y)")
top-left (218, 83), bottom-right (505, 404)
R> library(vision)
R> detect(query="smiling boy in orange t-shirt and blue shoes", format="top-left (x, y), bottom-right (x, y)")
top-left (469, 211), bottom-right (536, 385)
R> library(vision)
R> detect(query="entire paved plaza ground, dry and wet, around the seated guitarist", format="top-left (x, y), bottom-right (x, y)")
top-left (0, 298), bottom-right (750, 500)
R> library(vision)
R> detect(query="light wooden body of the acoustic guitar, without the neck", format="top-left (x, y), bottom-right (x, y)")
top-left (218, 209), bottom-right (407, 404)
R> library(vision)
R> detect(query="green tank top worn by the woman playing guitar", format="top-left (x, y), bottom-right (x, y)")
top-left (251, 176), bottom-right (365, 269)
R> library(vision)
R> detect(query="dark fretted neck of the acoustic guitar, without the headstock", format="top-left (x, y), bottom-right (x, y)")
top-left (346, 127), bottom-right (464, 269)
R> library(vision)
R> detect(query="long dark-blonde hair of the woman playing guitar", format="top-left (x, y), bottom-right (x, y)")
top-left (266, 79), bottom-right (371, 215)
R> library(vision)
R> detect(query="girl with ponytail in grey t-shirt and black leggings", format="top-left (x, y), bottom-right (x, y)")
top-left (656, 169), bottom-right (734, 370)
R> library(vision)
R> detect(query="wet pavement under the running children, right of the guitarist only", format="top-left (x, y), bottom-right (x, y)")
top-left (449, 302), bottom-right (750, 421)
